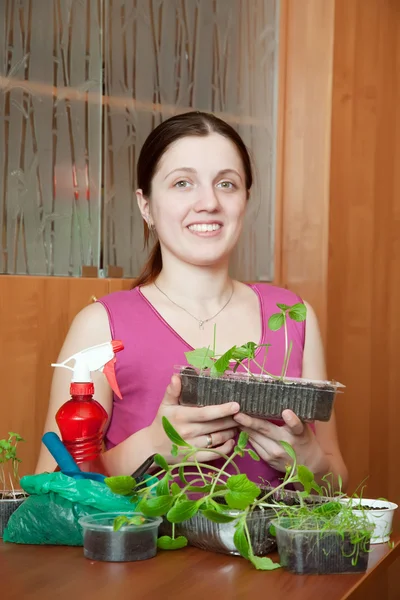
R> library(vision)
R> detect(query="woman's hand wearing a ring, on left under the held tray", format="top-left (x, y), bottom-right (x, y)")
top-left (147, 375), bottom-right (240, 464)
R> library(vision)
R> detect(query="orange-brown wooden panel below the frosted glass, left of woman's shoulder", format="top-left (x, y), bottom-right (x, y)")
top-left (0, 276), bottom-right (122, 474)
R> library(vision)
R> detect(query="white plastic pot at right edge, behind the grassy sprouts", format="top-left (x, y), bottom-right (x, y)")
top-left (340, 498), bottom-right (398, 544)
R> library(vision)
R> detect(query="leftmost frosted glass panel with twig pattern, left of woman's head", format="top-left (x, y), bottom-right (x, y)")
top-left (0, 0), bottom-right (102, 275)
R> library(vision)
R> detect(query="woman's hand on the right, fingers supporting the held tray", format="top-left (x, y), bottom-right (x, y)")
top-left (234, 409), bottom-right (330, 475)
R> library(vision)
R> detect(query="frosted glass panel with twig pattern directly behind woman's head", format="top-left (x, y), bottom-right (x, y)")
top-left (104, 0), bottom-right (279, 280)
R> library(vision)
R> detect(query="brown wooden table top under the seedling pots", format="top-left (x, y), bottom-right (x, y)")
top-left (0, 535), bottom-right (400, 600)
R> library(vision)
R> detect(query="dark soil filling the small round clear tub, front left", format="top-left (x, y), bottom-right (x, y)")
top-left (84, 530), bottom-right (157, 562)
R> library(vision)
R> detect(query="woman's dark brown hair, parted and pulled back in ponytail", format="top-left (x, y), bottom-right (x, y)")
top-left (133, 111), bottom-right (253, 287)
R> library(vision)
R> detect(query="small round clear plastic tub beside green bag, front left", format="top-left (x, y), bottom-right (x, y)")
top-left (79, 512), bottom-right (162, 562)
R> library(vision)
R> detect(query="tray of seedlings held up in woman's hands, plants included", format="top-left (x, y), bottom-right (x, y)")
top-left (177, 303), bottom-right (344, 421)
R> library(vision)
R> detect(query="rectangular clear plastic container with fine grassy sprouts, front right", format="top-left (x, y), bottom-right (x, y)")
top-left (272, 517), bottom-right (369, 575)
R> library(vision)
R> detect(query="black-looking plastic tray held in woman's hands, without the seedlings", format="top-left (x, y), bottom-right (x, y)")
top-left (175, 365), bottom-right (344, 421)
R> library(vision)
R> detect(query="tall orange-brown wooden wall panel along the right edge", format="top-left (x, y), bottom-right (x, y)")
top-left (327, 0), bottom-right (400, 503)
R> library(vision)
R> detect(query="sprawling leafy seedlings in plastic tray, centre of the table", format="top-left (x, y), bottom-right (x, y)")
top-left (105, 417), bottom-right (330, 570)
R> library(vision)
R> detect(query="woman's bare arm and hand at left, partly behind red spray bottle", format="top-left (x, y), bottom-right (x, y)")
top-left (35, 303), bottom-right (239, 475)
